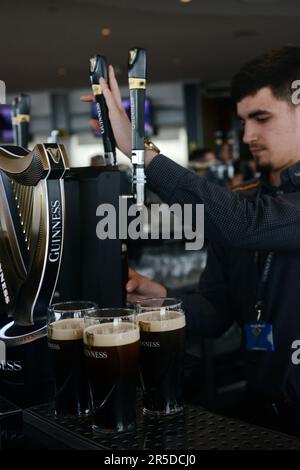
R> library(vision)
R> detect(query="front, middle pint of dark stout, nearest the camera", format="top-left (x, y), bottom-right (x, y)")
top-left (84, 322), bottom-right (140, 432)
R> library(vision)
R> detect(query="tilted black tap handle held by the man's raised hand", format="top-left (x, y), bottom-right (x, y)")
top-left (90, 55), bottom-right (116, 165)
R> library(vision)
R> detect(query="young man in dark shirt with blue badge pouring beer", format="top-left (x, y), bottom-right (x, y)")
top-left (81, 47), bottom-right (300, 431)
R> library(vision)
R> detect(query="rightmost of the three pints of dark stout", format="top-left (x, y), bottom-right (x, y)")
top-left (138, 310), bottom-right (185, 414)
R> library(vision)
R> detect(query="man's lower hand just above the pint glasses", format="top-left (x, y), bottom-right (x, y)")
top-left (126, 268), bottom-right (167, 303)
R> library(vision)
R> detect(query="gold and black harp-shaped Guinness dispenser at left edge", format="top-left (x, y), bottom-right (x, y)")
top-left (0, 144), bottom-right (68, 406)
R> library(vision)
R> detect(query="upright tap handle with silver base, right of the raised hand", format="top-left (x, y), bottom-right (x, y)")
top-left (128, 48), bottom-right (146, 206)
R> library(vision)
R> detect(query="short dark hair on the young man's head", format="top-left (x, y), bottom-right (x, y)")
top-left (231, 46), bottom-right (300, 104)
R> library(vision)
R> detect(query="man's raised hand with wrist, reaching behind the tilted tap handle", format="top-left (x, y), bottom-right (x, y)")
top-left (80, 65), bottom-right (157, 166)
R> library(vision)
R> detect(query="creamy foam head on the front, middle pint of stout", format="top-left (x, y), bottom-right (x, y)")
top-left (83, 322), bottom-right (140, 347)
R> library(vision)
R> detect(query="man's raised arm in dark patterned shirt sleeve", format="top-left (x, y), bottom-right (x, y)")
top-left (146, 155), bottom-right (300, 251)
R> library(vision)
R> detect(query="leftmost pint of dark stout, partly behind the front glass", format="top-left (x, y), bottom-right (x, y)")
top-left (48, 318), bottom-right (88, 414)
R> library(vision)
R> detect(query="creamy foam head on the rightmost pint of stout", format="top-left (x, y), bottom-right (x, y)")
top-left (138, 310), bottom-right (185, 332)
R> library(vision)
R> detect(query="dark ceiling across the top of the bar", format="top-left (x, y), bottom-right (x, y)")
top-left (0, 0), bottom-right (300, 93)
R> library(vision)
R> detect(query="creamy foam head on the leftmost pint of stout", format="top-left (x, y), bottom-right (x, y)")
top-left (48, 318), bottom-right (84, 341)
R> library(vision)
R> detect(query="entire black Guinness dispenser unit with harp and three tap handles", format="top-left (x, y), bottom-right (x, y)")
top-left (0, 48), bottom-right (146, 407)
